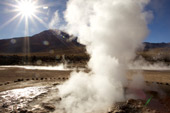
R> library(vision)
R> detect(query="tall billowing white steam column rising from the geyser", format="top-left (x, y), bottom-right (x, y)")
top-left (59, 0), bottom-right (150, 113)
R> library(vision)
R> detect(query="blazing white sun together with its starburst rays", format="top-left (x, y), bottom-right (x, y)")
top-left (0, 0), bottom-right (49, 36)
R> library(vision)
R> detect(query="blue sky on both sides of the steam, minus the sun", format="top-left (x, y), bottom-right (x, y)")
top-left (0, 0), bottom-right (170, 42)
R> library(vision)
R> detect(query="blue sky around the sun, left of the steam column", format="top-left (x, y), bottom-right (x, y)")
top-left (0, 0), bottom-right (67, 39)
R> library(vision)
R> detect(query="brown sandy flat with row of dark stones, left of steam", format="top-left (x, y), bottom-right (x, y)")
top-left (0, 68), bottom-right (71, 91)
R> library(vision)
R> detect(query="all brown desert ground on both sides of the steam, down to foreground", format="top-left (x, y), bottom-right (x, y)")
top-left (0, 67), bottom-right (170, 113)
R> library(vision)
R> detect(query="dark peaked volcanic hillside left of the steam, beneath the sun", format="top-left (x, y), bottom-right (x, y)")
top-left (0, 30), bottom-right (84, 54)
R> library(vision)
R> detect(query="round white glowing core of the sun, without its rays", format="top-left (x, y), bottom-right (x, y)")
top-left (16, 0), bottom-right (37, 17)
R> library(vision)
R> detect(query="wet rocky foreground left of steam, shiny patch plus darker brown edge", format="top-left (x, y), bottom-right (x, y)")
top-left (0, 83), bottom-right (58, 113)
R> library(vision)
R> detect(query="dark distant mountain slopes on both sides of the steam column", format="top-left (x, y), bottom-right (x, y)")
top-left (0, 30), bottom-right (170, 60)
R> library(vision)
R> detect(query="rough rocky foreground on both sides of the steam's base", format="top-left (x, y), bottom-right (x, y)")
top-left (0, 82), bottom-right (170, 113)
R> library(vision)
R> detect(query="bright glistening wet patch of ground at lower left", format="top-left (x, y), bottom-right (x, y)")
top-left (0, 86), bottom-right (49, 113)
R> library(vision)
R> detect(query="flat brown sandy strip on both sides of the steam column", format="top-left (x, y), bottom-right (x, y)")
top-left (0, 67), bottom-right (170, 85)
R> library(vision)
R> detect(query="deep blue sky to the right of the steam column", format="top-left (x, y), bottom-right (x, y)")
top-left (145, 0), bottom-right (170, 42)
